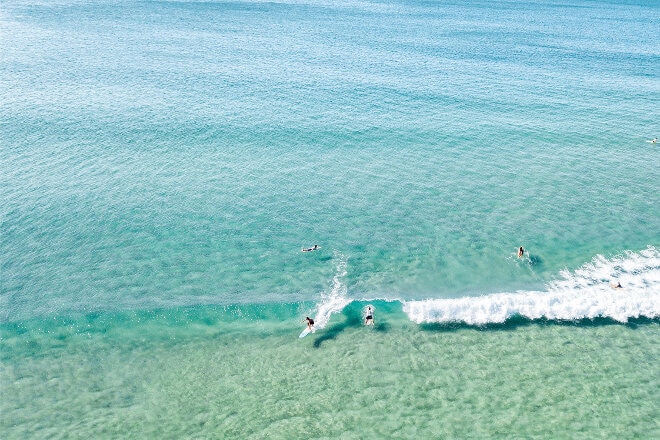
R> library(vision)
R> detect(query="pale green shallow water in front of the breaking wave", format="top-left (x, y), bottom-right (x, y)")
top-left (1, 303), bottom-right (660, 438)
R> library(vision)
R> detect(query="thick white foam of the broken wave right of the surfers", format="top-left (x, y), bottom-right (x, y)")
top-left (403, 246), bottom-right (660, 325)
